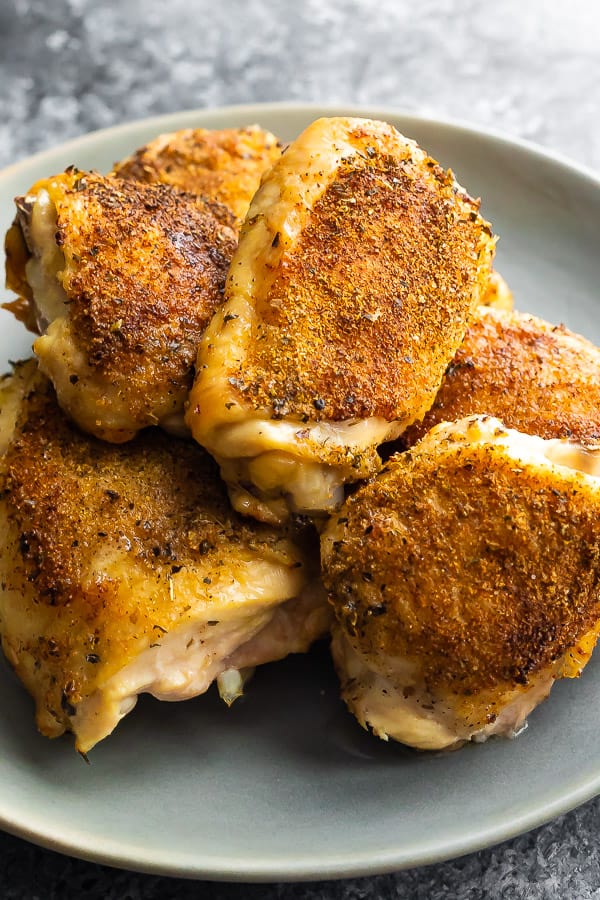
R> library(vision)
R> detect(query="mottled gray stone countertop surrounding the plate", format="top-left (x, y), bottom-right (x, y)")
top-left (0, 0), bottom-right (600, 900)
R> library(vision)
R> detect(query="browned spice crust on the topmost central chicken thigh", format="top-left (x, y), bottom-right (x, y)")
top-left (239, 141), bottom-right (493, 421)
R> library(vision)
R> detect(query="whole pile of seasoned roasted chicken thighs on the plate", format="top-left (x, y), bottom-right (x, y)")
top-left (0, 118), bottom-right (600, 754)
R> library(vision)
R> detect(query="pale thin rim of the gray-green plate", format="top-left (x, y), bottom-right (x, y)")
top-left (0, 101), bottom-right (600, 883)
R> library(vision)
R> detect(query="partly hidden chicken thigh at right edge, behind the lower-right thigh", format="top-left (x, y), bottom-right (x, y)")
top-left (400, 309), bottom-right (600, 448)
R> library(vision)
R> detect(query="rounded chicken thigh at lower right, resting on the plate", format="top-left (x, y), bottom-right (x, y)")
top-left (322, 417), bottom-right (600, 749)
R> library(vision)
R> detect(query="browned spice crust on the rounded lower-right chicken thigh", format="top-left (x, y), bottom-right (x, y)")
top-left (324, 448), bottom-right (600, 702)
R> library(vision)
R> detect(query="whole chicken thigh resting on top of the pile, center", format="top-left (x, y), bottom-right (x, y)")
top-left (187, 118), bottom-right (494, 521)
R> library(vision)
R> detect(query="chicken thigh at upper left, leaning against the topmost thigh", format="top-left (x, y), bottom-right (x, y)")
top-left (11, 169), bottom-right (235, 442)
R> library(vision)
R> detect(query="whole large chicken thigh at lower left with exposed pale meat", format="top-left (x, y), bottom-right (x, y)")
top-left (0, 362), bottom-right (330, 752)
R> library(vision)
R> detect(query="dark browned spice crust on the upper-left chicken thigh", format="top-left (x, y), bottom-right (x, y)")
top-left (44, 171), bottom-right (235, 424)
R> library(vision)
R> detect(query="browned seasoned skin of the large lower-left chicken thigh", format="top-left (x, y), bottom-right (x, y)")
top-left (0, 366), bottom-right (302, 734)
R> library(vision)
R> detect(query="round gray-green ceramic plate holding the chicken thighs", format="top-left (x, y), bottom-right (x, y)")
top-left (0, 104), bottom-right (600, 881)
